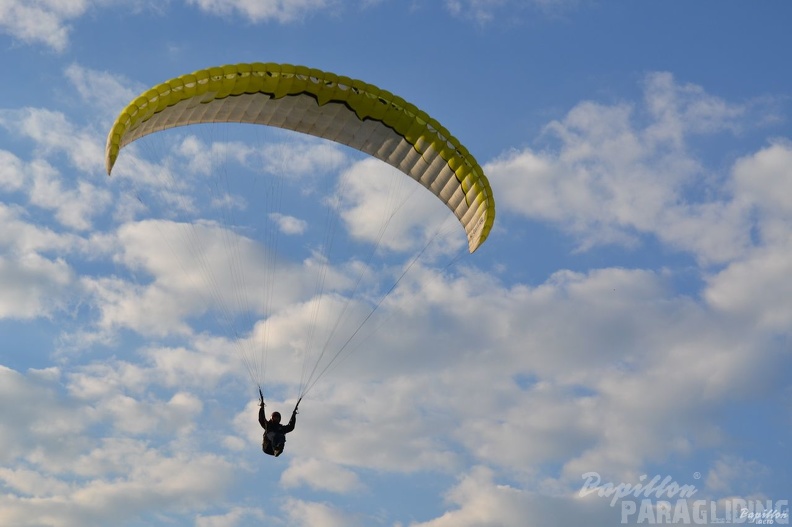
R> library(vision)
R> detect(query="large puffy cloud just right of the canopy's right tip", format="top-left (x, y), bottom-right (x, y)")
top-left (486, 73), bottom-right (751, 263)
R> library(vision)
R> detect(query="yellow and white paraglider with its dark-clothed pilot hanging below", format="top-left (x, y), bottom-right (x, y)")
top-left (105, 63), bottom-right (495, 456)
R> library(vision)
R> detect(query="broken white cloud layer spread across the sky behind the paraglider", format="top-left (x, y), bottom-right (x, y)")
top-left (0, 7), bottom-right (792, 527)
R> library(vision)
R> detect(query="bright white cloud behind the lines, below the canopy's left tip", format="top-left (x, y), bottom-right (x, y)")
top-left (94, 220), bottom-right (318, 335)
